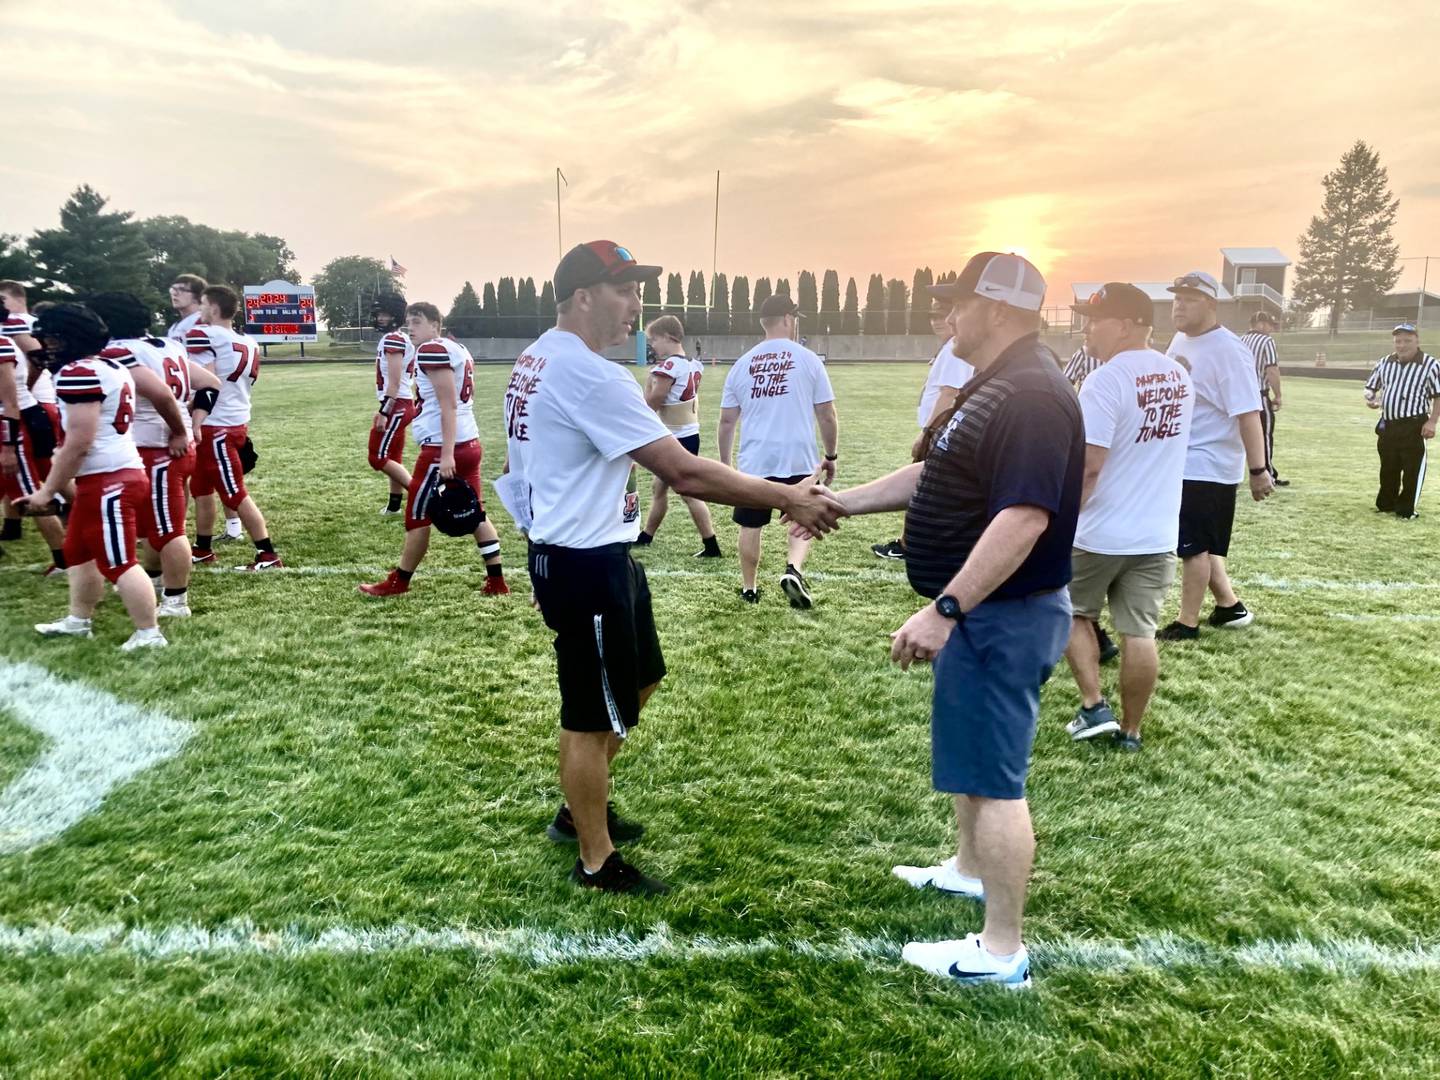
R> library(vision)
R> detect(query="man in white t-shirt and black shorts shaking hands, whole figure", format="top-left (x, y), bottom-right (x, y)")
top-left (503, 240), bottom-right (841, 894)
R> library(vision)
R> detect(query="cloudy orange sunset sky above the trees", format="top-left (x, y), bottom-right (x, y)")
top-left (11, 0), bottom-right (1440, 308)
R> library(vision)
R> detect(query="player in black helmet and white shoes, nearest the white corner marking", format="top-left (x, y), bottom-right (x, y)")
top-left (19, 304), bottom-right (186, 652)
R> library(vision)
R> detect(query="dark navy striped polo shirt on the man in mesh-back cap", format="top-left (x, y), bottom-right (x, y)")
top-left (904, 334), bottom-right (1084, 599)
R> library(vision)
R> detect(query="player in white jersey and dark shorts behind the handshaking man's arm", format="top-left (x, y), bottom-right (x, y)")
top-left (635, 315), bottom-right (720, 559)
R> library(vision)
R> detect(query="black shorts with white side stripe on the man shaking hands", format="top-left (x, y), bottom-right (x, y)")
top-left (530, 544), bottom-right (665, 739)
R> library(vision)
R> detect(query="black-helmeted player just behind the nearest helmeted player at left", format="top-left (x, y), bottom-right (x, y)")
top-left (86, 292), bottom-right (220, 618)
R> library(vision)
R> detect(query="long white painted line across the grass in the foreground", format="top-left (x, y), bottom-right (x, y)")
top-left (0, 920), bottom-right (1440, 978)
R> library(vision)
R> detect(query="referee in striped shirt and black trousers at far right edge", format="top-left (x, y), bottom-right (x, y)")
top-left (1365, 323), bottom-right (1440, 521)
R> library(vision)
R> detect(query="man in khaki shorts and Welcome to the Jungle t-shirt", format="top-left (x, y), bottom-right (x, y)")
top-left (1066, 281), bottom-right (1194, 750)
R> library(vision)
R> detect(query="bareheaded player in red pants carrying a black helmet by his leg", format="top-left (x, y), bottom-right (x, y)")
top-left (360, 302), bottom-right (510, 596)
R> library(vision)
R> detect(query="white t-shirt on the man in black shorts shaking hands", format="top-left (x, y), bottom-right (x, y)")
top-left (505, 328), bottom-right (670, 547)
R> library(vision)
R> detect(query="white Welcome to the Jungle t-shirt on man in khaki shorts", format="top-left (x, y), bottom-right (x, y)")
top-left (1074, 348), bottom-right (1195, 554)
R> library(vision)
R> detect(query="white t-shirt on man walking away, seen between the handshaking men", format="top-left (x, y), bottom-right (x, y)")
top-left (720, 338), bottom-right (835, 477)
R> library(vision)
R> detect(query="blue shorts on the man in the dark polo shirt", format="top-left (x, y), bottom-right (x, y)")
top-left (930, 589), bottom-right (1070, 799)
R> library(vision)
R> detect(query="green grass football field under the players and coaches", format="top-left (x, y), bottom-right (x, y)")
top-left (0, 366), bottom-right (1440, 1079)
